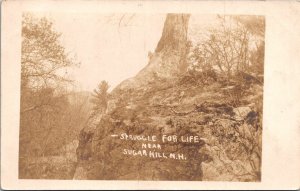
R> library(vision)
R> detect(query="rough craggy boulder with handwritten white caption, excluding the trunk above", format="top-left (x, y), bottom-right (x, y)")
top-left (78, 73), bottom-right (262, 181)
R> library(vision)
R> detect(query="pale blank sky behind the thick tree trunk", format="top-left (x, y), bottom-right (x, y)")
top-left (35, 12), bottom-right (216, 91)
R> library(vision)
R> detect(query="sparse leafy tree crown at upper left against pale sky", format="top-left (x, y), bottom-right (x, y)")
top-left (21, 14), bottom-right (79, 89)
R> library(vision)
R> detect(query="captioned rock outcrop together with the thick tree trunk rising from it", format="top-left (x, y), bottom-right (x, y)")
top-left (77, 14), bottom-right (262, 181)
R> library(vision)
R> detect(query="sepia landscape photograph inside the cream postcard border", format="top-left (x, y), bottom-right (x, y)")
top-left (19, 12), bottom-right (265, 182)
